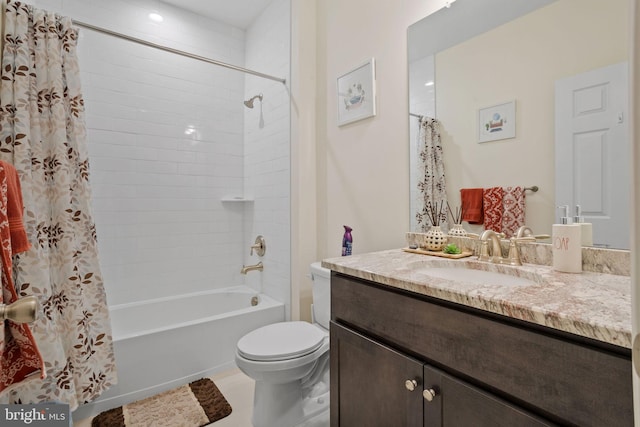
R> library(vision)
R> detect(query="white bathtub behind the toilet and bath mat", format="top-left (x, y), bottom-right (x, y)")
top-left (73, 286), bottom-right (285, 420)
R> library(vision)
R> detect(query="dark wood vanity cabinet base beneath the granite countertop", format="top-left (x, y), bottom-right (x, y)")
top-left (330, 273), bottom-right (633, 427)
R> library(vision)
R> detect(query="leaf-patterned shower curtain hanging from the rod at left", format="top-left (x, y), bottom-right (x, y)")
top-left (0, 0), bottom-right (116, 410)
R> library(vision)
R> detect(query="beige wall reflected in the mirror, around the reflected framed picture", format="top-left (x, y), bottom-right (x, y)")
top-left (435, 0), bottom-right (629, 234)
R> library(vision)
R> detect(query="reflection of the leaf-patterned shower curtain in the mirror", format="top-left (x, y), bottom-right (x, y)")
top-left (416, 117), bottom-right (449, 232)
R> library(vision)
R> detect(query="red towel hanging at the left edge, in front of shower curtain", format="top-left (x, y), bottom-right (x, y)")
top-left (0, 161), bottom-right (46, 392)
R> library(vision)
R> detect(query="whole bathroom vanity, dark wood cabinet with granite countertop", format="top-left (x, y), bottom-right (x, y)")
top-left (323, 250), bottom-right (633, 427)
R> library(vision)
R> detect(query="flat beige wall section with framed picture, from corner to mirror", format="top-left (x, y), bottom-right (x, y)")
top-left (316, 0), bottom-right (445, 257)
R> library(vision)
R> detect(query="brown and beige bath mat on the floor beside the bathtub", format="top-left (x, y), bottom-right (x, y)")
top-left (91, 378), bottom-right (231, 427)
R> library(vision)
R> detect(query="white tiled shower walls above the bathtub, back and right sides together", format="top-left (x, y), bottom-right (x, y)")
top-left (31, 0), bottom-right (290, 314)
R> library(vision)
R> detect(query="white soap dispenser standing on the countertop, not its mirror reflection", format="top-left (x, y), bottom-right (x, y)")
top-left (551, 205), bottom-right (582, 273)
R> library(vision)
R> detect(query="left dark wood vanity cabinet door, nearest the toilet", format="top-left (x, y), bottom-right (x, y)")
top-left (330, 322), bottom-right (423, 427)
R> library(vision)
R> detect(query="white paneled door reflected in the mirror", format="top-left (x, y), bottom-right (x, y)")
top-left (555, 62), bottom-right (631, 249)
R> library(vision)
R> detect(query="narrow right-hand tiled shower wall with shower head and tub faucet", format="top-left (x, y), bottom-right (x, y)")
top-left (243, 0), bottom-right (291, 313)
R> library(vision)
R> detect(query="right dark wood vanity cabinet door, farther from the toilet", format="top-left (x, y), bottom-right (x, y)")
top-left (424, 365), bottom-right (555, 427)
